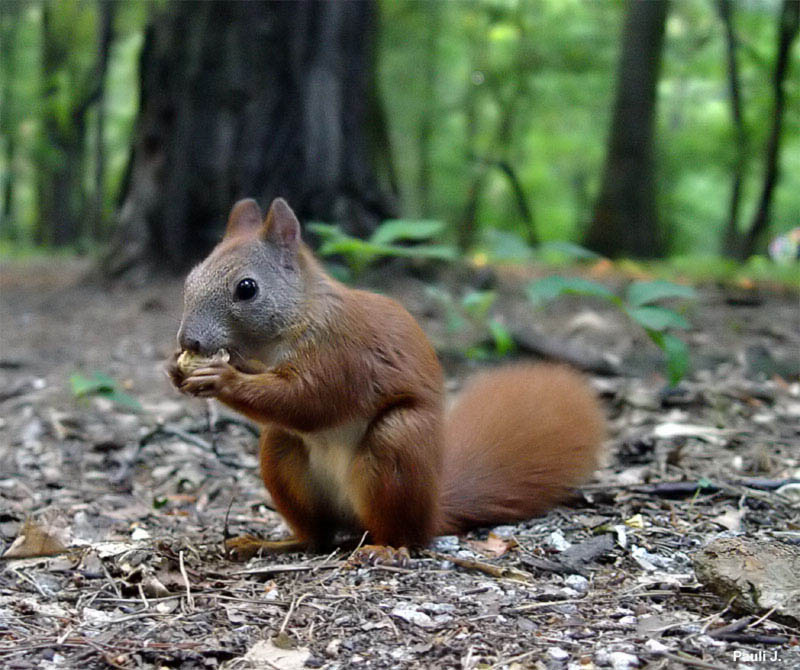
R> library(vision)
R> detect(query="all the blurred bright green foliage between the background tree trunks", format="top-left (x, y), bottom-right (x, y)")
top-left (0, 0), bottom-right (800, 266)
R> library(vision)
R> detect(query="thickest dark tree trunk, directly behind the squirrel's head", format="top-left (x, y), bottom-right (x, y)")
top-left (104, 1), bottom-right (393, 274)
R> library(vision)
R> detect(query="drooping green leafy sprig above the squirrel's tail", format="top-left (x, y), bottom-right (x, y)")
top-left (527, 276), bottom-right (697, 386)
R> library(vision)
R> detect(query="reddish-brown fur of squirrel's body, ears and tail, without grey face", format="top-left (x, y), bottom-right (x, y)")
top-left (171, 203), bottom-right (604, 547)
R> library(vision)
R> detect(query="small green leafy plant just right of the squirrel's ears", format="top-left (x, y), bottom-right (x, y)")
top-left (308, 219), bottom-right (458, 275)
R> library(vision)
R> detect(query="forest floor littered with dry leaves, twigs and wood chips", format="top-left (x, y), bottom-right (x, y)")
top-left (0, 261), bottom-right (800, 670)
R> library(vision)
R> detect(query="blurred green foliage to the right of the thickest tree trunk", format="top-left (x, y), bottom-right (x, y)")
top-left (378, 0), bottom-right (800, 262)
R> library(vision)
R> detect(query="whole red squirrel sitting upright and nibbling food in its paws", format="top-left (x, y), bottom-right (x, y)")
top-left (169, 198), bottom-right (605, 555)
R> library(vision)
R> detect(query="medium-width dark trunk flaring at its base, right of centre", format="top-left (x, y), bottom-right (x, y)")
top-left (586, 0), bottom-right (667, 257)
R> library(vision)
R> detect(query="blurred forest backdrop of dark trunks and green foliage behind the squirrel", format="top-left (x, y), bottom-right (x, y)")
top-left (0, 0), bottom-right (800, 274)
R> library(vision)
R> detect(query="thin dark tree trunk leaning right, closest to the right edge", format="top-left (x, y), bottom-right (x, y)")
top-left (738, 0), bottom-right (800, 260)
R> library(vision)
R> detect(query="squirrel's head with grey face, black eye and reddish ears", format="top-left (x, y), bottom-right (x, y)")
top-left (178, 198), bottom-right (306, 360)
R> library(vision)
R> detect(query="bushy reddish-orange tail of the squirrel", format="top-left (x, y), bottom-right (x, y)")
top-left (437, 364), bottom-right (605, 534)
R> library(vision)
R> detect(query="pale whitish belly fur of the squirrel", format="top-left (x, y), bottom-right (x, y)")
top-left (301, 419), bottom-right (367, 517)
